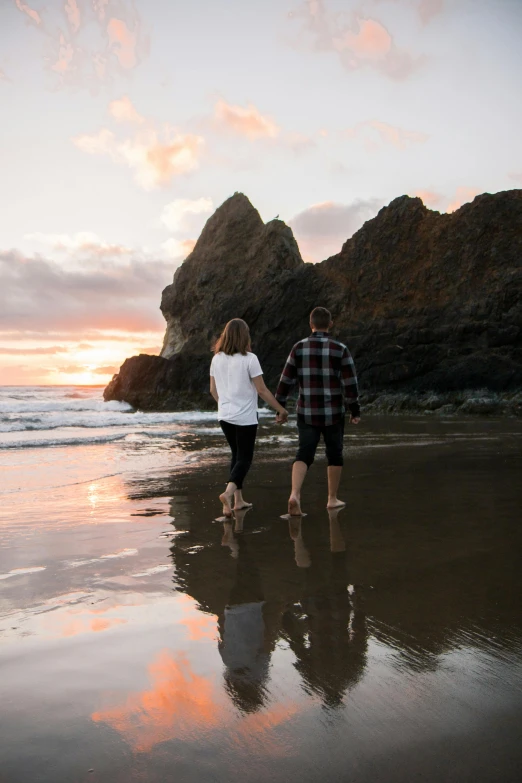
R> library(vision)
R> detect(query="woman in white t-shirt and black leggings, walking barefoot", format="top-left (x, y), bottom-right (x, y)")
top-left (210, 318), bottom-right (288, 517)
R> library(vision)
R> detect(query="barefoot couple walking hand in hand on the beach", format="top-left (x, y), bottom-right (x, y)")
top-left (210, 307), bottom-right (360, 517)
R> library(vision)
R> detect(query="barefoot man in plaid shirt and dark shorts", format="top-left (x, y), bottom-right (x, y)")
top-left (276, 307), bottom-right (360, 516)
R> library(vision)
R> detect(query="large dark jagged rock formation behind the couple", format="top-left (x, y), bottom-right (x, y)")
top-left (104, 190), bottom-right (522, 410)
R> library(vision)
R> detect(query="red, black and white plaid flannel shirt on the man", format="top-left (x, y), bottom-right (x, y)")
top-left (275, 332), bottom-right (359, 427)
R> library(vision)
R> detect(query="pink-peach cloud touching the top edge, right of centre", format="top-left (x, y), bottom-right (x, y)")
top-left (290, 0), bottom-right (418, 80)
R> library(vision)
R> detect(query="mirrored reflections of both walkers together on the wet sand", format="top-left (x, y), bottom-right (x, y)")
top-left (219, 509), bottom-right (366, 712)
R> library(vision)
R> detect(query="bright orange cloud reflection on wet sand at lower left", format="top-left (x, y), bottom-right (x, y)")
top-left (91, 650), bottom-right (222, 753)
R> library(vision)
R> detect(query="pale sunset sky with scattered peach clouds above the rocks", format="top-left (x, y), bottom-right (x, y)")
top-left (0, 0), bottom-right (522, 385)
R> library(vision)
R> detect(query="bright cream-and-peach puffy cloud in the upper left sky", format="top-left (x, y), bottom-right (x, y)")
top-left (73, 108), bottom-right (204, 190)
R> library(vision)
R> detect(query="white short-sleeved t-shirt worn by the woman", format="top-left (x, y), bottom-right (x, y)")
top-left (210, 351), bottom-right (263, 427)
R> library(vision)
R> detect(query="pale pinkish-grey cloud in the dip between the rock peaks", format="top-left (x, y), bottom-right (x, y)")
top-left (289, 199), bottom-right (384, 262)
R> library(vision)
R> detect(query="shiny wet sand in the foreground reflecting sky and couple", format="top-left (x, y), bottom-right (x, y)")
top-left (0, 418), bottom-right (522, 783)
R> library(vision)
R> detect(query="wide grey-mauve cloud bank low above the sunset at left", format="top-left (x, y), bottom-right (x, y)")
top-left (0, 250), bottom-right (172, 340)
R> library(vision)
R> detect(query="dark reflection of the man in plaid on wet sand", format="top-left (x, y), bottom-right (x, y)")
top-left (283, 509), bottom-right (366, 707)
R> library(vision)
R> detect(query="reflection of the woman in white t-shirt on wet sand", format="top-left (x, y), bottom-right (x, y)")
top-left (218, 512), bottom-right (277, 712)
